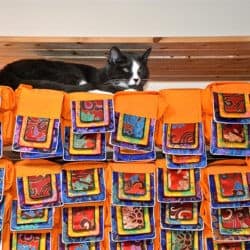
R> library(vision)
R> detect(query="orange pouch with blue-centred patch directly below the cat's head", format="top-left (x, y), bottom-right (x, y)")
top-left (110, 91), bottom-right (158, 152)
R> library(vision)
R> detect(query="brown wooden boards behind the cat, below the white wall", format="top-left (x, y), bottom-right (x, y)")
top-left (0, 36), bottom-right (250, 81)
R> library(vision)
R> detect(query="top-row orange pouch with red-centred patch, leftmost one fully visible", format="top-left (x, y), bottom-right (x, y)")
top-left (12, 85), bottom-right (64, 157)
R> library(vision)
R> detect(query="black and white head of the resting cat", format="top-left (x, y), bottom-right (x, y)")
top-left (103, 47), bottom-right (151, 90)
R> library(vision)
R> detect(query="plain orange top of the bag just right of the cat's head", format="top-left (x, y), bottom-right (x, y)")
top-left (156, 89), bottom-right (202, 145)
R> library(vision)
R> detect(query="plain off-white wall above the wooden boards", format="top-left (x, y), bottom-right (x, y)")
top-left (0, 0), bottom-right (250, 36)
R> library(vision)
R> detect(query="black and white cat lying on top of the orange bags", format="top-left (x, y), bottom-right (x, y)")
top-left (0, 47), bottom-right (151, 93)
